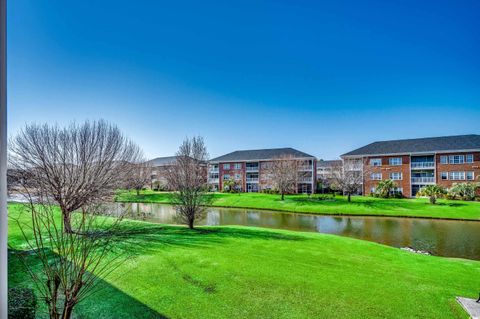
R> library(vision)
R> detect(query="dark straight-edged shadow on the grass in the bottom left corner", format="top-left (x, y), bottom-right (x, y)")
top-left (8, 250), bottom-right (168, 319)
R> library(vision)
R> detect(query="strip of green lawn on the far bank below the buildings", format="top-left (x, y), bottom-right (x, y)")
top-left (116, 190), bottom-right (480, 220)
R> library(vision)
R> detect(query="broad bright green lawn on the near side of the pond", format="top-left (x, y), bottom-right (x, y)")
top-left (9, 205), bottom-right (480, 318)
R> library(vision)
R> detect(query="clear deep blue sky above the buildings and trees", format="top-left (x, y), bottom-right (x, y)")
top-left (8, 0), bottom-right (480, 159)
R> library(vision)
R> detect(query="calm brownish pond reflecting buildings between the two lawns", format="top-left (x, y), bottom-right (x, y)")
top-left (118, 203), bottom-right (480, 260)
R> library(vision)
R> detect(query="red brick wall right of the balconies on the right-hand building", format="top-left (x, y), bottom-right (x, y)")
top-left (435, 152), bottom-right (480, 188)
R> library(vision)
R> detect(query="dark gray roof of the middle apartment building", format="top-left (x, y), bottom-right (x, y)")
top-left (211, 148), bottom-right (314, 162)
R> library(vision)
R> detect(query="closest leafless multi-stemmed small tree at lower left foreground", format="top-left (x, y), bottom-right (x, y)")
top-left (12, 197), bottom-right (130, 319)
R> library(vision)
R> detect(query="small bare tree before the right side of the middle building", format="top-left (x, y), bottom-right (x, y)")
top-left (266, 156), bottom-right (300, 201)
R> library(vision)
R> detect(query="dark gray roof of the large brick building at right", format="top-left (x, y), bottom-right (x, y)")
top-left (342, 134), bottom-right (480, 157)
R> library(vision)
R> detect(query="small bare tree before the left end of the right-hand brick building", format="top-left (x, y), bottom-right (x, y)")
top-left (331, 164), bottom-right (365, 202)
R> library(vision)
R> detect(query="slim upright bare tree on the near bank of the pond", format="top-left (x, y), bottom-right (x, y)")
top-left (166, 136), bottom-right (212, 229)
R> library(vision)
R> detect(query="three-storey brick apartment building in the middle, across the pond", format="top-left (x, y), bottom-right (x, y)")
top-left (208, 148), bottom-right (316, 193)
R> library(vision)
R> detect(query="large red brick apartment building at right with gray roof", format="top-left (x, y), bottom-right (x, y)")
top-left (341, 135), bottom-right (480, 197)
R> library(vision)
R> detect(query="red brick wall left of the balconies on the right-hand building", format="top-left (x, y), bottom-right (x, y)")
top-left (363, 155), bottom-right (412, 197)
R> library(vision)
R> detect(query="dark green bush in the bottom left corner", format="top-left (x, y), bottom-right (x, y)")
top-left (8, 288), bottom-right (37, 319)
